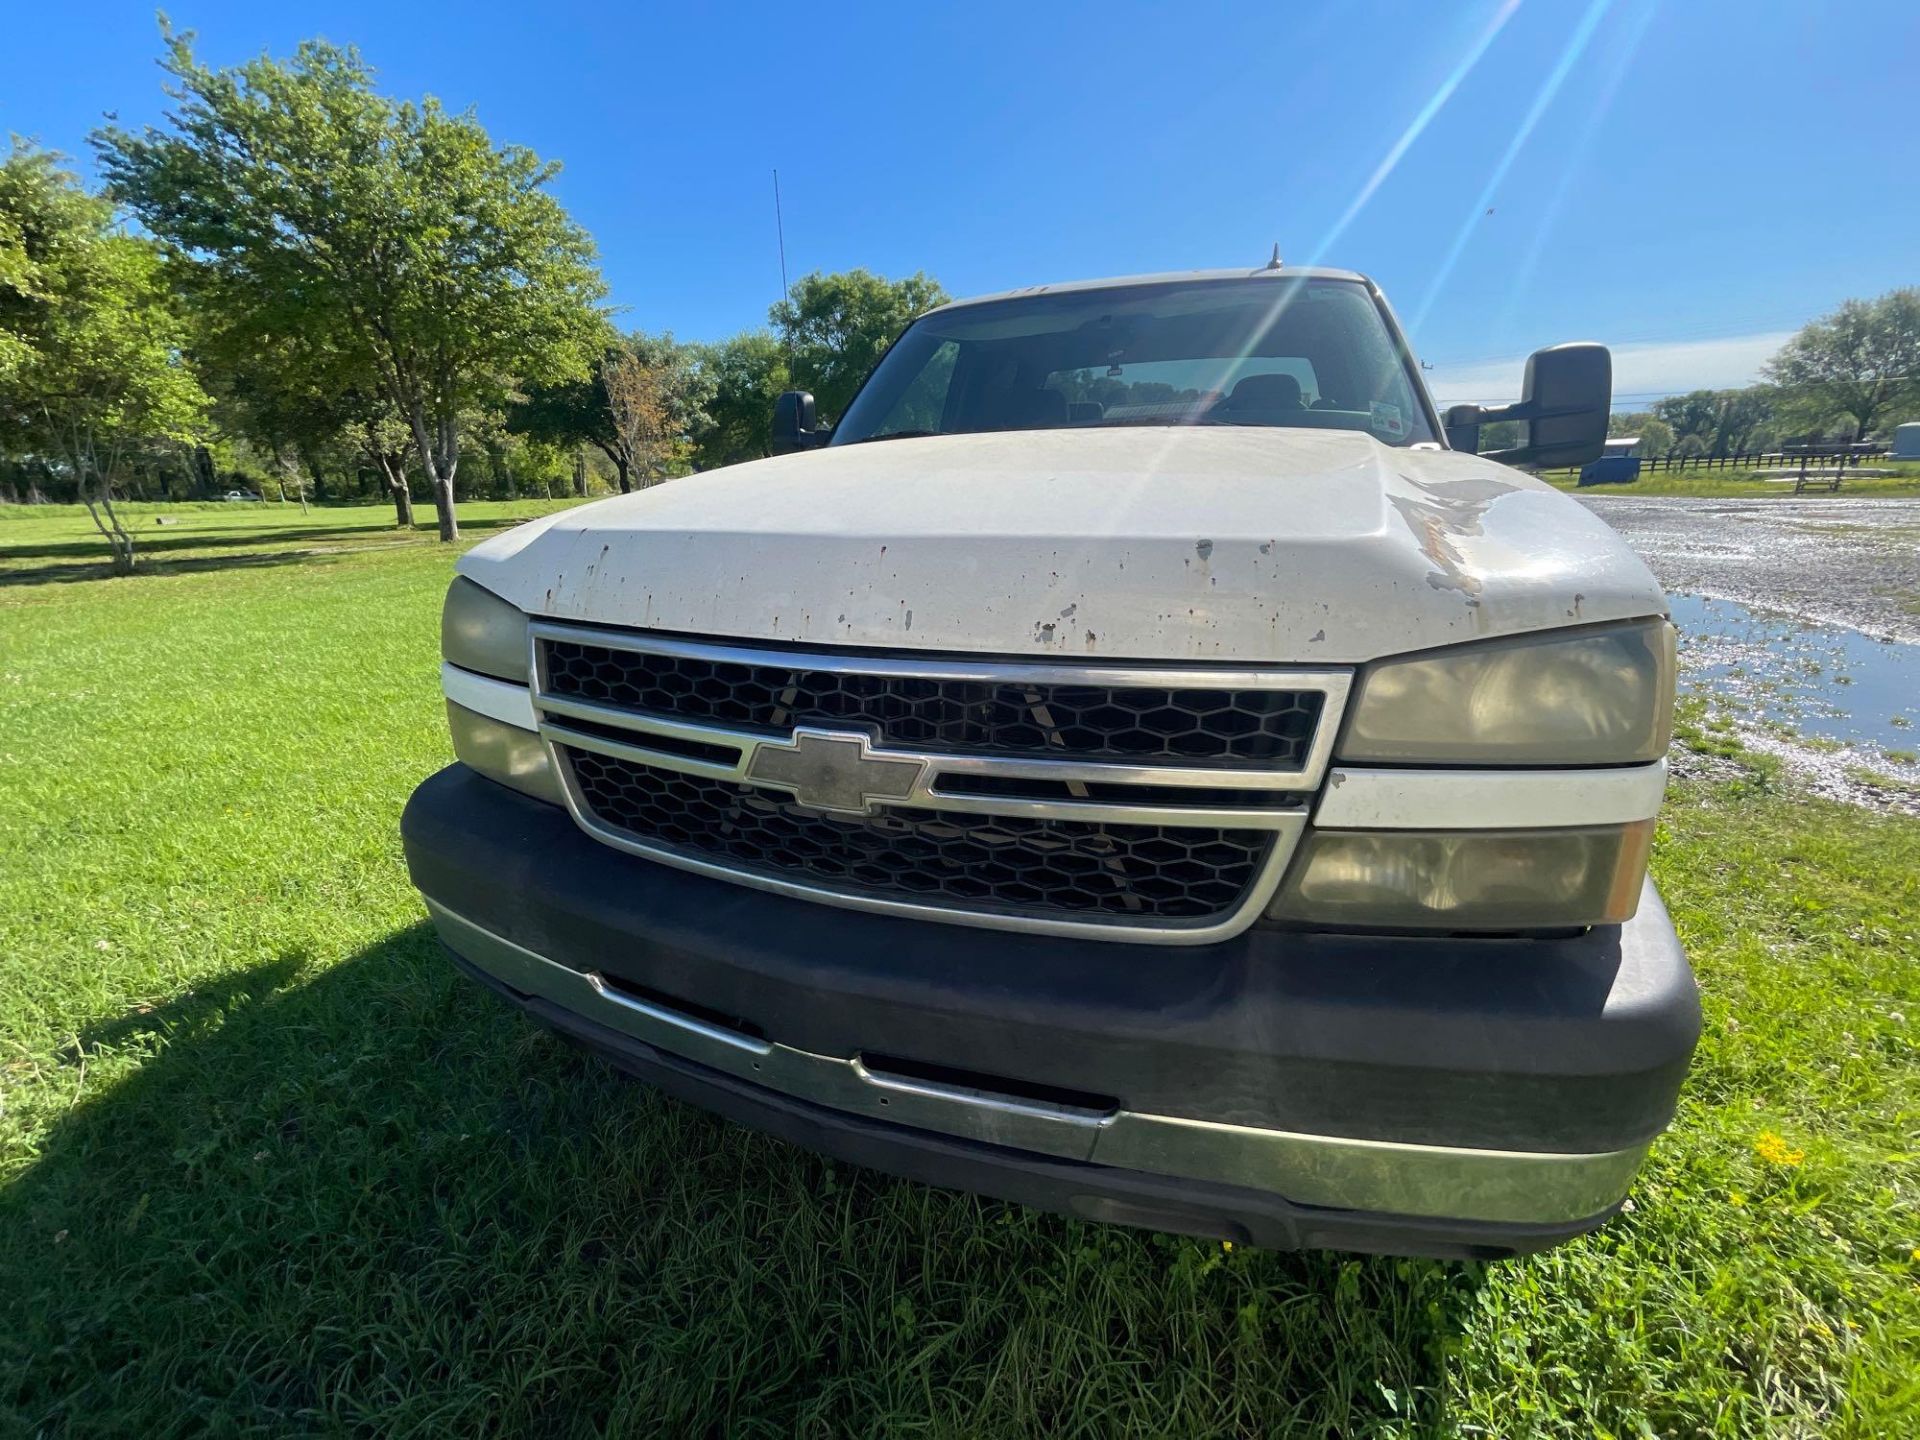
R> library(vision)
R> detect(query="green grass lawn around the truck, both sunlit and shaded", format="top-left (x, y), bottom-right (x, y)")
top-left (0, 507), bottom-right (1920, 1440)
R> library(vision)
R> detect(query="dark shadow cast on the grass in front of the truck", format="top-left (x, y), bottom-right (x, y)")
top-left (0, 925), bottom-right (1476, 1436)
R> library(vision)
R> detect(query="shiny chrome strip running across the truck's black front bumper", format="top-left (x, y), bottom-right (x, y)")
top-left (426, 900), bottom-right (1647, 1225)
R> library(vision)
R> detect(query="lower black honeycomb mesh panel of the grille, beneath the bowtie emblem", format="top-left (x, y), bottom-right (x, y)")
top-left (563, 747), bottom-right (1273, 920)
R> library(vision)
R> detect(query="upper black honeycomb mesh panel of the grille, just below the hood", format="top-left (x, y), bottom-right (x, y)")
top-left (545, 639), bottom-right (1325, 770)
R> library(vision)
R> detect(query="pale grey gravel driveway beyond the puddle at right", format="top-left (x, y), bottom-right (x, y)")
top-left (1580, 495), bottom-right (1920, 643)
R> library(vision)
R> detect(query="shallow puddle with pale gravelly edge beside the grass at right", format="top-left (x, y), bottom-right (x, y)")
top-left (1670, 593), bottom-right (1920, 812)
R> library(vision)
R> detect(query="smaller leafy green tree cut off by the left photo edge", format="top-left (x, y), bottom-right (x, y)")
top-left (0, 142), bottom-right (207, 574)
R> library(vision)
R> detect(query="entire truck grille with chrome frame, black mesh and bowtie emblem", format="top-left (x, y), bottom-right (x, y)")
top-left (532, 620), bottom-right (1352, 945)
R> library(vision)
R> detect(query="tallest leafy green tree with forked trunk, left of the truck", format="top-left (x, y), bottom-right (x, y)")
top-left (94, 27), bottom-right (605, 540)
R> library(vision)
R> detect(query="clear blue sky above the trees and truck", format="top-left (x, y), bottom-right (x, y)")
top-left (0, 0), bottom-right (1920, 405)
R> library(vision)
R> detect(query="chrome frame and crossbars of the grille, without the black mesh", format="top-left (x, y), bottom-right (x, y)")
top-left (532, 620), bottom-right (1352, 945)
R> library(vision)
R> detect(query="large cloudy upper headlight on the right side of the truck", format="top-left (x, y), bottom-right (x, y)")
top-left (1340, 620), bottom-right (1674, 766)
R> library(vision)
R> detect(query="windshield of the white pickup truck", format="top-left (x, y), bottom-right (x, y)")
top-left (833, 280), bottom-right (1434, 445)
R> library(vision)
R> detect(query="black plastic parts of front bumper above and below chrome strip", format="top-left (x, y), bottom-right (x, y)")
top-left (401, 766), bottom-right (1699, 1254)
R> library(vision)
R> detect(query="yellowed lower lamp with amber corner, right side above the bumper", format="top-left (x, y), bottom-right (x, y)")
top-left (1267, 820), bottom-right (1653, 929)
